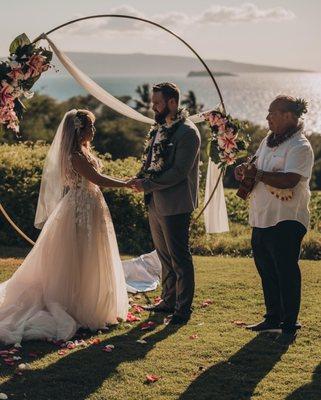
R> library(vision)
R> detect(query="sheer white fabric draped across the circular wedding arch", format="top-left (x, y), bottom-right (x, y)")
top-left (42, 34), bottom-right (229, 233)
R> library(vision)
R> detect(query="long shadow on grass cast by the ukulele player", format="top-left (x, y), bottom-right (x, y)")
top-left (179, 335), bottom-right (287, 400)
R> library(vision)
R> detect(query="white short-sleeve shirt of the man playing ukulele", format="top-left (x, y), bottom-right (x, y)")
top-left (249, 129), bottom-right (314, 229)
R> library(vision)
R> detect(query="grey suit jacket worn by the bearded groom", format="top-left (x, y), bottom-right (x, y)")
top-left (143, 119), bottom-right (201, 216)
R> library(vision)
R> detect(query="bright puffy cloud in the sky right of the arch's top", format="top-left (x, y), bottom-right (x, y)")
top-left (197, 3), bottom-right (296, 24)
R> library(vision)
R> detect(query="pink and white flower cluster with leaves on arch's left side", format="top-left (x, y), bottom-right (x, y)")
top-left (0, 33), bottom-right (52, 133)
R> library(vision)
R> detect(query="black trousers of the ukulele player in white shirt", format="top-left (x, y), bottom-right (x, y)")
top-left (252, 221), bottom-right (306, 332)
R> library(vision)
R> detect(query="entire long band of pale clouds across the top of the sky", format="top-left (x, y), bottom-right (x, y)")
top-left (57, 3), bottom-right (296, 37)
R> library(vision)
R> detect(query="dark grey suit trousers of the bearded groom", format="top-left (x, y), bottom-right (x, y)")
top-left (149, 200), bottom-right (195, 317)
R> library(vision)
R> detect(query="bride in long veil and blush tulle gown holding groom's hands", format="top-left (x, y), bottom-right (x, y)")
top-left (0, 110), bottom-right (128, 344)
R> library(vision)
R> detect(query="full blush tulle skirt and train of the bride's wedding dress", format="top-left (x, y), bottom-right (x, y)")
top-left (0, 152), bottom-right (128, 344)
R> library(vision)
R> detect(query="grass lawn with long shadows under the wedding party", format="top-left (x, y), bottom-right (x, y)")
top-left (0, 257), bottom-right (321, 400)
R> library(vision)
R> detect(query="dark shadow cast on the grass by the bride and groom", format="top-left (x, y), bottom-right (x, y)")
top-left (0, 317), bottom-right (179, 400)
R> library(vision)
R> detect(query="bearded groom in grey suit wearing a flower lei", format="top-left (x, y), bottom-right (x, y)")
top-left (131, 82), bottom-right (200, 325)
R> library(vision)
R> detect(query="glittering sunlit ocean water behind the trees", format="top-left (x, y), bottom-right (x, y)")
top-left (34, 73), bottom-right (321, 133)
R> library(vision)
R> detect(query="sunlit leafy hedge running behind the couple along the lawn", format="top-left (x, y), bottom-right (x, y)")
top-left (0, 142), bottom-right (321, 259)
